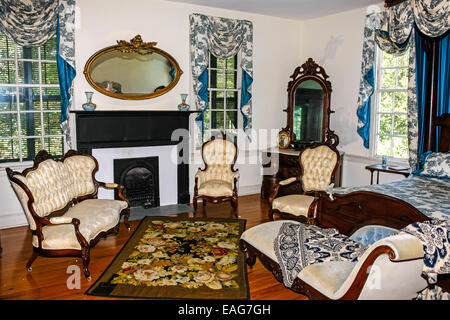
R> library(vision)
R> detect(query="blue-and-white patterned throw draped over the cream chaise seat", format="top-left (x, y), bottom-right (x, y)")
top-left (274, 222), bottom-right (367, 288)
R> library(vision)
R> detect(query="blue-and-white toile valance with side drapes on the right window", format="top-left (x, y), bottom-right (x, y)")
top-left (357, 0), bottom-right (449, 168)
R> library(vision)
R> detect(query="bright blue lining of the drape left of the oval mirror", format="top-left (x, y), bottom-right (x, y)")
top-left (56, 19), bottom-right (76, 123)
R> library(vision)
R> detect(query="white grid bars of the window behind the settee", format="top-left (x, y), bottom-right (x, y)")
top-left (0, 36), bottom-right (66, 167)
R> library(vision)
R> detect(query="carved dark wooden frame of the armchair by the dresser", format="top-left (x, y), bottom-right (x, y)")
top-left (268, 142), bottom-right (341, 224)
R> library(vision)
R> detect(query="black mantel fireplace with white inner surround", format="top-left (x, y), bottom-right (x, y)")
top-left (71, 110), bottom-right (198, 206)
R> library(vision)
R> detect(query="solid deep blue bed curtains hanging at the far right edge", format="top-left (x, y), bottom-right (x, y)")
top-left (414, 27), bottom-right (450, 169)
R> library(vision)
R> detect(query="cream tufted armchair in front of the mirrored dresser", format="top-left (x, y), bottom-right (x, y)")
top-left (269, 144), bottom-right (340, 224)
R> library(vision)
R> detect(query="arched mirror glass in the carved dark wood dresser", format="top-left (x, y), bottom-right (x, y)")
top-left (293, 80), bottom-right (324, 143)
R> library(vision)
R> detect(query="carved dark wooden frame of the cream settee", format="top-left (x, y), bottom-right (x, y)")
top-left (6, 150), bottom-right (130, 280)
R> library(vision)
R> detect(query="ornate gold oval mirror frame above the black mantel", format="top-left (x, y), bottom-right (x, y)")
top-left (83, 35), bottom-right (183, 100)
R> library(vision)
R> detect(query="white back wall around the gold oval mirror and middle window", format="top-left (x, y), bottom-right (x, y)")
top-left (0, 0), bottom-right (302, 228)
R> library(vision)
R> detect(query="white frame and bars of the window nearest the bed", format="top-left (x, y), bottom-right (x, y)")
top-left (370, 47), bottom-right (409, 162)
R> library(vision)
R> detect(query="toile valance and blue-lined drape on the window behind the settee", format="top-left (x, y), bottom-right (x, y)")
top-left (0, 0), bottom-right (75, 148)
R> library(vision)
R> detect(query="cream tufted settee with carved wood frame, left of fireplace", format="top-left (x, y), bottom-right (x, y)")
top-left (6, 150), bottom-right (130, 280)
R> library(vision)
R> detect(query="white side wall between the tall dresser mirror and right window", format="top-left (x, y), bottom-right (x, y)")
top-left (299, 3), bottom-right (410, 186)
